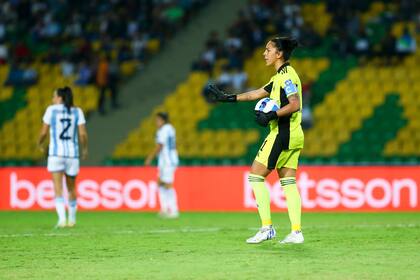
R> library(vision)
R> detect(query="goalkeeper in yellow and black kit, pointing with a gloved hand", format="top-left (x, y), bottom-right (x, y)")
top-left (207, 37), bottom-right (304, 244)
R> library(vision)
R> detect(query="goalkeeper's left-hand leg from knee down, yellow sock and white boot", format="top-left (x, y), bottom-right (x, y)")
top-left (246, 161), bottom-right (276, 244)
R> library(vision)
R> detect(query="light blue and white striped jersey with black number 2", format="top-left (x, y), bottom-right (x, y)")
top-left (42, 104), bottom-right (86, 158)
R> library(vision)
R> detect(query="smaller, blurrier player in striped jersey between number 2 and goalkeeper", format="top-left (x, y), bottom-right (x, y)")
top-left (145, 112), bottom-right (179, 218)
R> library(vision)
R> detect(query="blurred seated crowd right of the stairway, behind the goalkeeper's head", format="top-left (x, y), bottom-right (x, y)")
top-left (198, 0), bottom-right (420, 127)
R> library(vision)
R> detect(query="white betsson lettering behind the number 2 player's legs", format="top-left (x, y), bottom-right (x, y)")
top-left (10, 172), bottom-right (157, 209)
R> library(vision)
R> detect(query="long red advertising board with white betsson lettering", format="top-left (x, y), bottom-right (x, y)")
top-left (0, 166), bottom-right (420, 211)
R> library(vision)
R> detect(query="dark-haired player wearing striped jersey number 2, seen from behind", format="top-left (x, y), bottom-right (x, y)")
top-left (38, 87), bottom-right (88, 227)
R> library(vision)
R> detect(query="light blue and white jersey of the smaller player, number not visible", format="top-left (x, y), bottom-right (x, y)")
top-left (156, 123), bottom-right (179, 166)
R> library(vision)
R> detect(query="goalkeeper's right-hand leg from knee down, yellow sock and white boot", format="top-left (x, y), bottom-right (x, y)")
top-left (277, 167), bottom-right (304, 244)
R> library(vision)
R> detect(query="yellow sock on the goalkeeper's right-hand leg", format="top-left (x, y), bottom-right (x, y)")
top-left (280, 177), bottom-right (301, 231)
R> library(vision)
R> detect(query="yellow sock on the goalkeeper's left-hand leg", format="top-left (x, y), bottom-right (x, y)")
top-left (248, 174), bottom-right (272, 227)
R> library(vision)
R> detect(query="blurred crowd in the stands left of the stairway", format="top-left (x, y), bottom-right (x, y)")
top-left (0, 0), bottom-right (210, 112)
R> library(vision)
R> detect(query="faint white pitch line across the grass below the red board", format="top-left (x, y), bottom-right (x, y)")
top-left (0, 223), bottom-right (420, 238)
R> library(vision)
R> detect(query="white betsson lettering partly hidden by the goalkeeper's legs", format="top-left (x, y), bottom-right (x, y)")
top-left (244, 172), bottom-right (418, 209)
